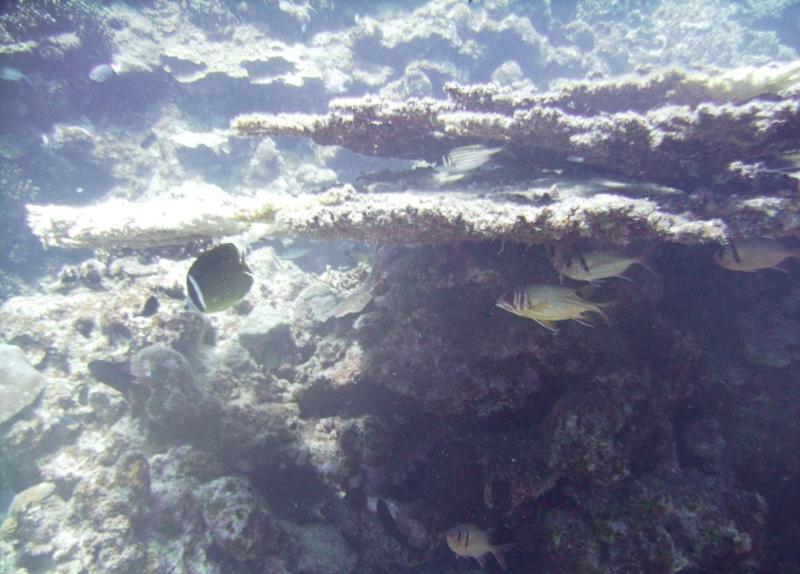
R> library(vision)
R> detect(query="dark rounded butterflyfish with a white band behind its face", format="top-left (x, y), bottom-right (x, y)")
top-left (186, 243), bottom-right (253, 313)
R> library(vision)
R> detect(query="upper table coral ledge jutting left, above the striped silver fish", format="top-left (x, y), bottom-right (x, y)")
top-left (232, 61), bottom-right (800, 184)
